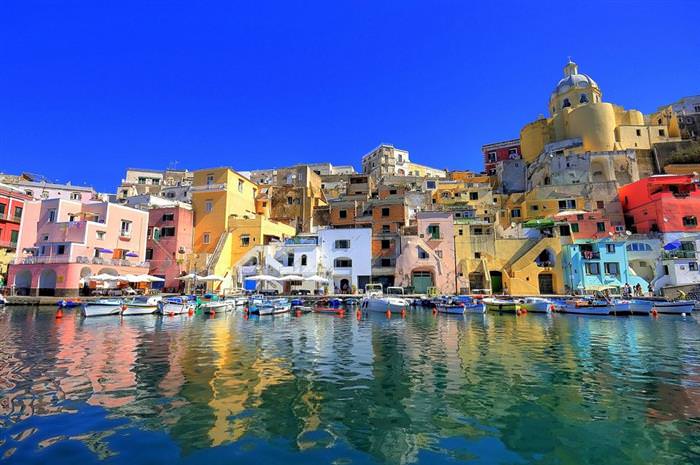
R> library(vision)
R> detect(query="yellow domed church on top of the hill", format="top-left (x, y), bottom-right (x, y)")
top-left (520, 61), bottom-right (678, 163)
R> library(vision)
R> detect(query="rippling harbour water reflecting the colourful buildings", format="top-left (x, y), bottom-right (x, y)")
top-left (0, 307), bottom-right (700, 465)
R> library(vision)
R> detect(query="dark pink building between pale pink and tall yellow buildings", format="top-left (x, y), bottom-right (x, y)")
top-left (146, 204), bottom-right (193, 291)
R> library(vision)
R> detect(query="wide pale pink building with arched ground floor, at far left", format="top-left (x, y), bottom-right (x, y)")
top-left (8, 199), bottom-right (149, 296)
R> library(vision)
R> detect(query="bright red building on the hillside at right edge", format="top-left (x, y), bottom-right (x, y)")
top-left (619, 174), bottom-right (700, 234)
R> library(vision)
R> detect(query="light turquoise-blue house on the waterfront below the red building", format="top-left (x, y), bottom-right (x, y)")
top-left (562, 239), bottom-right (649, 292)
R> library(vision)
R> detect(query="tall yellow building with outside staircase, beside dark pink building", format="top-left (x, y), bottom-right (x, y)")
top-left (191, 167), bottom-right (295, 276)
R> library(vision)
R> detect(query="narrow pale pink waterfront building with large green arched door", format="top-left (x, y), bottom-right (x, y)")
top-left (395, 212), bottom-right (456, 294)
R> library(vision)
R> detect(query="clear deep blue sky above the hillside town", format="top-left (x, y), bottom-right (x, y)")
top-left (0, 0), bottom-right (700, 191)
